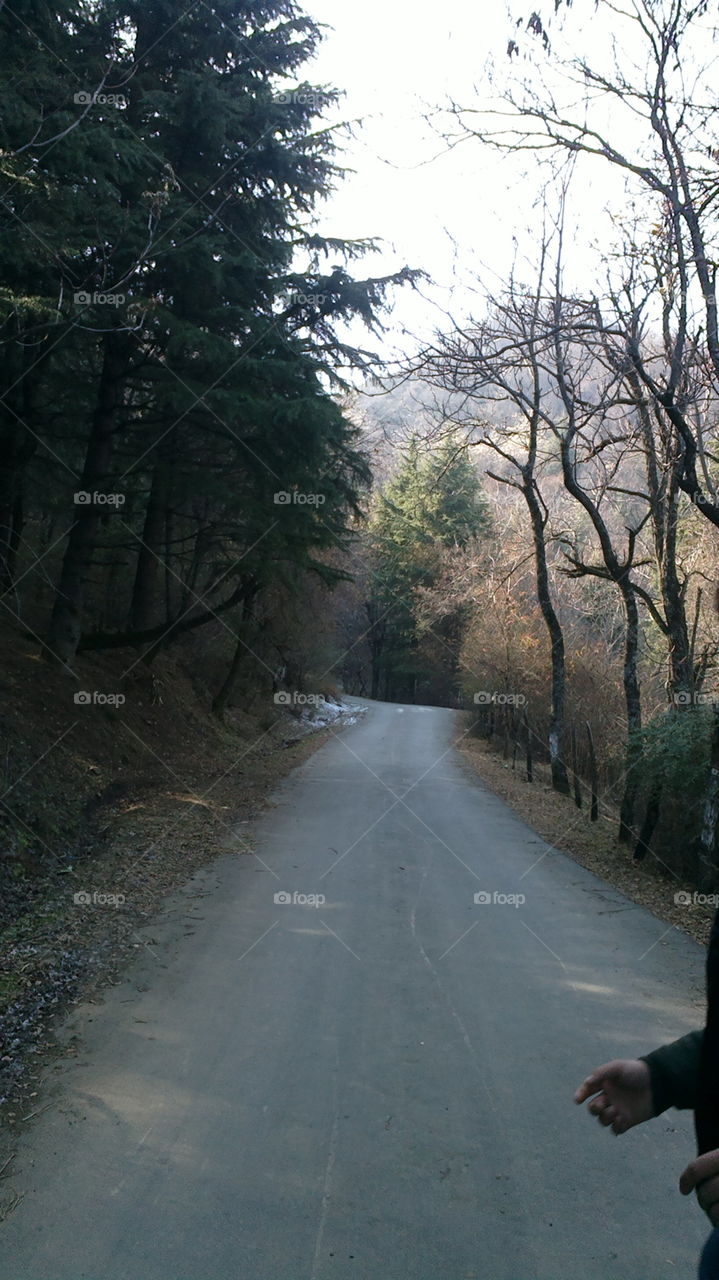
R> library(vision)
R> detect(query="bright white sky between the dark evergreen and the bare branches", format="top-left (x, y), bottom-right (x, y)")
top-left (304, 0), bottom-right (621, 358)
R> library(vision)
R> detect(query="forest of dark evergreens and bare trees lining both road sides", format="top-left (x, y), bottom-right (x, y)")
top-left (0, 0), bottom-right (719, 906)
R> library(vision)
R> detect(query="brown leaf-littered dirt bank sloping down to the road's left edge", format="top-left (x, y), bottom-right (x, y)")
top-left (0, 632), bottom-right (347, 1128)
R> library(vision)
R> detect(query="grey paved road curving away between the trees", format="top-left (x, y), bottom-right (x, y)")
top-left (0, 704), bottom-right (705, 1280)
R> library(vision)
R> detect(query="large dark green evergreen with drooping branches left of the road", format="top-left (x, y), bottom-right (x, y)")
top-left (0, 0), bottom-right (415, 664)
